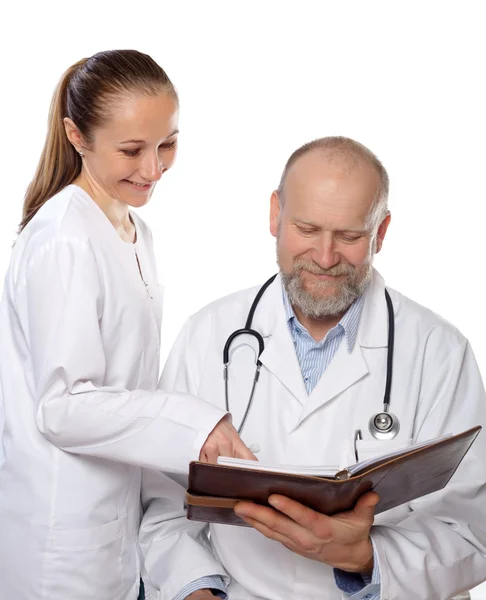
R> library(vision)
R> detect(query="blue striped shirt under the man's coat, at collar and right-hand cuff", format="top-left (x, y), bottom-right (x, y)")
top-left (282, 288), bottom-right (380, 600)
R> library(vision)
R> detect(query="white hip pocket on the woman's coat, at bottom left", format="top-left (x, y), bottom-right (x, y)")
top-left (46, 517), bottom-right (126, 600)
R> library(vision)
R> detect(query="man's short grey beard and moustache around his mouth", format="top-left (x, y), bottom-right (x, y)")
top-left (280, 260), bottom-right (373, 319)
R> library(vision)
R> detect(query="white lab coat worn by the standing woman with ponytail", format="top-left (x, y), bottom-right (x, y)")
top-left (0, 185), bottom-right (224, 600)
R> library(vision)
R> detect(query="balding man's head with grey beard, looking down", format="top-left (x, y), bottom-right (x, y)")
top-left (270, 137), bottom-right (390, 320)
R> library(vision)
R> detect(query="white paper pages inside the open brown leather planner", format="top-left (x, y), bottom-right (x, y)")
top-left (218, 433), bottom-right (452, 479)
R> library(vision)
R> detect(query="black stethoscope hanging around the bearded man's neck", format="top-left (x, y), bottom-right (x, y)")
top-left (223, 274), bottom-right (400, 440)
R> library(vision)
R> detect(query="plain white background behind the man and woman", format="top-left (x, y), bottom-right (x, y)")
top-left (0, 0), bottom-right (486, 599)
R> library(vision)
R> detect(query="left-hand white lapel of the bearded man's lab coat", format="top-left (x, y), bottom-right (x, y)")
top-left (254, 276), bottom-right (307, 405)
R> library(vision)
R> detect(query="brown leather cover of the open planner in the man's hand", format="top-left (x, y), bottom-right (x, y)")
top-left (186, 426), bottom-right (481, 526)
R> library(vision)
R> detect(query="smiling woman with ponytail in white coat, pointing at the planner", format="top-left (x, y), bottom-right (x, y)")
top-left (0, 51), bottom-right (249, 600)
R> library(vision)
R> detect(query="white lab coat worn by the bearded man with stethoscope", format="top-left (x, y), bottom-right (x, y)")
top-left (141, 272), bottom-right (486, 600)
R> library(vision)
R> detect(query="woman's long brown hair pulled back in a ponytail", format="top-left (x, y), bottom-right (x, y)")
top-left (20, 50), bottom-right (177, 230)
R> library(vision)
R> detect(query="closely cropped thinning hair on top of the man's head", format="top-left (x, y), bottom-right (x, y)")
top-left (277, 136), bottom-right (389, 229)
